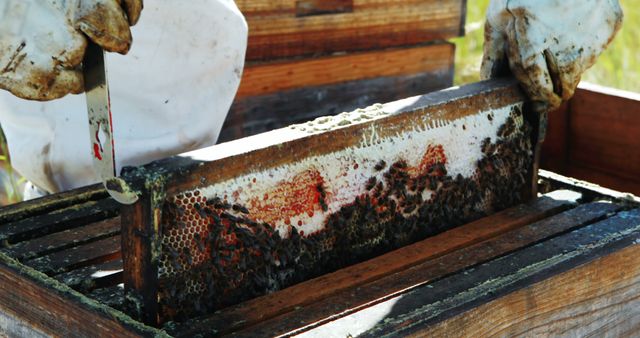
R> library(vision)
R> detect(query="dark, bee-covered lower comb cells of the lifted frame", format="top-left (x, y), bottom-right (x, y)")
top-left (159, 105), bottom-right (532, 320)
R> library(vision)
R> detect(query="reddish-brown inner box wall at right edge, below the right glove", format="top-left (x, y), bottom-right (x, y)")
top-left (542, 84), bottom-right (640, 194)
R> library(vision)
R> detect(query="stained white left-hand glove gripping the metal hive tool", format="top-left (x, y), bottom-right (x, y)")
top-left (0, 0), bottom-right (142, 100)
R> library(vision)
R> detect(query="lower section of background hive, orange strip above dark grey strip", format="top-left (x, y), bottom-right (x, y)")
top-left (218, 43), bottom-right (454, 142)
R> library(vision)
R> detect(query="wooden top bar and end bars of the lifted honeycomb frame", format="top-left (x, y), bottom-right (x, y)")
top-left (122, 80), bottom-right (539, 324)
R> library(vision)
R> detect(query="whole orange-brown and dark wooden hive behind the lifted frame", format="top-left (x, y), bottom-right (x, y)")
top-left (220, 0), bottom-right (466, 141)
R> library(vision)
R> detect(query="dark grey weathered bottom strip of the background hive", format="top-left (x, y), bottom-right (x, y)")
top-left (219, 68), bottom-right (453, 142)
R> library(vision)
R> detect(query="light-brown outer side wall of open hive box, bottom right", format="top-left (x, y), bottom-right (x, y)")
top-left (420, 236), bottom-right (640, 337)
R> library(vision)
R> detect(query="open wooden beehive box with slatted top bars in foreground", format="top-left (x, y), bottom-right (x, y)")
top-left (0, 83), bottom-right (640, 337)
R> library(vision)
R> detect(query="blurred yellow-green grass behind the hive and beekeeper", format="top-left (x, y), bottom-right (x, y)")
top-left (0, 0), bottom-right (640, 205)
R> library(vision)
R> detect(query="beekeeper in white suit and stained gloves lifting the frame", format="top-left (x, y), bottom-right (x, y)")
top-left (0, 0), bottom-right (622, 197)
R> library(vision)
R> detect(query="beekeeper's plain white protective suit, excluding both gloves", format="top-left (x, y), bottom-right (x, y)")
top-left (0, 0), bottom-right (248, 192)
